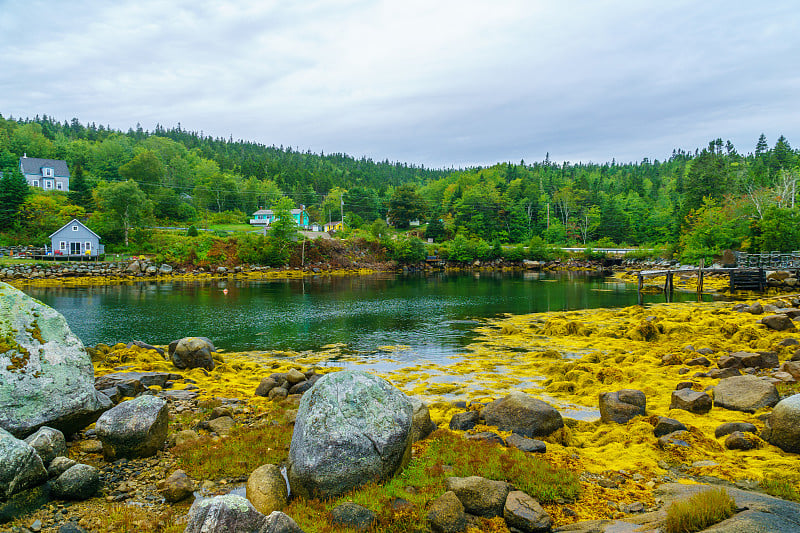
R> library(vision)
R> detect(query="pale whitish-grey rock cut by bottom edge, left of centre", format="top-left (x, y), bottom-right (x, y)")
top-left (184, 494), bottom-right (267, 533)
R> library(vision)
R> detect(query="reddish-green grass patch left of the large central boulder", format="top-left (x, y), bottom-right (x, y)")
top-left (172, 413), bottom-right (292, 479)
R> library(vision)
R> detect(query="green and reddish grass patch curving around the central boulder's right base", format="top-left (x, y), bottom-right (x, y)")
top-left (286, 430), bottom-right (580, 533)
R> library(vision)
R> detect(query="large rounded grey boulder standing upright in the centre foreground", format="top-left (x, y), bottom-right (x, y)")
top-left (288, 371), bottom-right (413, 498)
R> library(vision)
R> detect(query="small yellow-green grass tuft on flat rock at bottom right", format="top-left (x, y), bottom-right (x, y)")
top-left (664, 489), bottom-right (736, 533)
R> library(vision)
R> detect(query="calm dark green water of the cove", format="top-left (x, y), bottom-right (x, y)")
top-left (25, 272), bottom-right (708, 361)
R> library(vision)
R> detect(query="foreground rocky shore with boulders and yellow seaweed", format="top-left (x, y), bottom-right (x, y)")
top-left (0, 284), bottom-right (800, 532)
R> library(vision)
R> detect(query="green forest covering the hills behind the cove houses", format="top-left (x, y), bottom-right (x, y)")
top-left (0, 115), bottom-right (800, 262)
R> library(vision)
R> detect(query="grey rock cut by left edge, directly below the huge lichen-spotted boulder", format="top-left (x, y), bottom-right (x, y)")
top-left (0, 428), bottom-right (47, 500)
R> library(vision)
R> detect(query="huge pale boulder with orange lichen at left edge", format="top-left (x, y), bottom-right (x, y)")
top-left (0, 282), bottom-right (111, 438)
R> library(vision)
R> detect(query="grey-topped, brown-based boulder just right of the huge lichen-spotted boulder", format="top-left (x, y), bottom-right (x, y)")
top-left (95, 396), bottom-right (169, 460)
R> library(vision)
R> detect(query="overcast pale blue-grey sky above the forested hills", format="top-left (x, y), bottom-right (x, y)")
top-left (0, 0), bottom-right (800, 168)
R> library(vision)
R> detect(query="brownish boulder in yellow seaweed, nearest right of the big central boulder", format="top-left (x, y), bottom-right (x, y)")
top-left (481, 392), bottom-right (564, 437)
